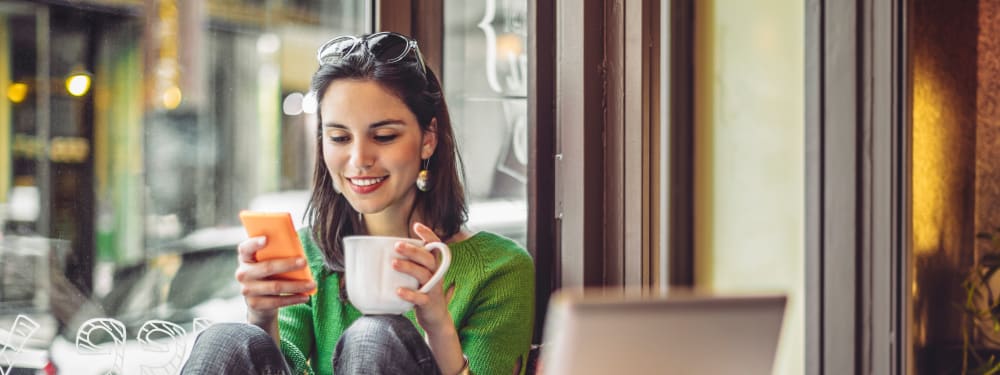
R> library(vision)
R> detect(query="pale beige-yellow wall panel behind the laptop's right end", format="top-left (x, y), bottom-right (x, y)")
top-left (695, 0), bottom-right (805, 374)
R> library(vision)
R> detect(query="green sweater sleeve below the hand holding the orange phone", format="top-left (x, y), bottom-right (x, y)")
top-left (278, 298), bottom-right (315, 375)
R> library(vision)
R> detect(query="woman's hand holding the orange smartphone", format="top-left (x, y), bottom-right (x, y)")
top-left (236, 237), bottom-right (316, 331)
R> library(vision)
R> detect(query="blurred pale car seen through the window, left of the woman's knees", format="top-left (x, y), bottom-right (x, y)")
top-left (51, 227), bottom-right (246, 374)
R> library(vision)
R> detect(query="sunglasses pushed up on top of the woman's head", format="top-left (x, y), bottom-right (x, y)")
top-left (316, 31), bottom-right (426, 72)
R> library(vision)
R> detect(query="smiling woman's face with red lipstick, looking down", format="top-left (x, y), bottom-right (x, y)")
top-left (320, 79), bottom-right (436, 217)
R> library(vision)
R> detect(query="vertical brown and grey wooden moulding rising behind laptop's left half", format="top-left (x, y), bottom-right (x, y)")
top-left (554, 0), bottom-right (660, 290)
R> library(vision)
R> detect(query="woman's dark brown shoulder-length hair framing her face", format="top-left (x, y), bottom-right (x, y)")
top-left (306, 36), bottom-right (468, 271)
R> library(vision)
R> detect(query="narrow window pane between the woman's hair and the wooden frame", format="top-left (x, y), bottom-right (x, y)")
top-left (443, 0), bottom-right (528, 245)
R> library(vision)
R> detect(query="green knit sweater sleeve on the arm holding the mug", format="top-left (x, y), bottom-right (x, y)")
top-left (459, 249), bottom-right (535, 375)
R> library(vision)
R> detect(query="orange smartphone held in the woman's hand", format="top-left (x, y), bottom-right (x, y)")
top-left (240, 210), bottom-right (316, 295)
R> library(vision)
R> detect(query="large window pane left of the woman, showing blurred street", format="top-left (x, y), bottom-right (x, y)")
top-left (0, 0), bottom-right (373, 374)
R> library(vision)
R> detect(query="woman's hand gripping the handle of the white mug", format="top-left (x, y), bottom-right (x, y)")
top-left (392, 223), bottom-right (454, 333)
